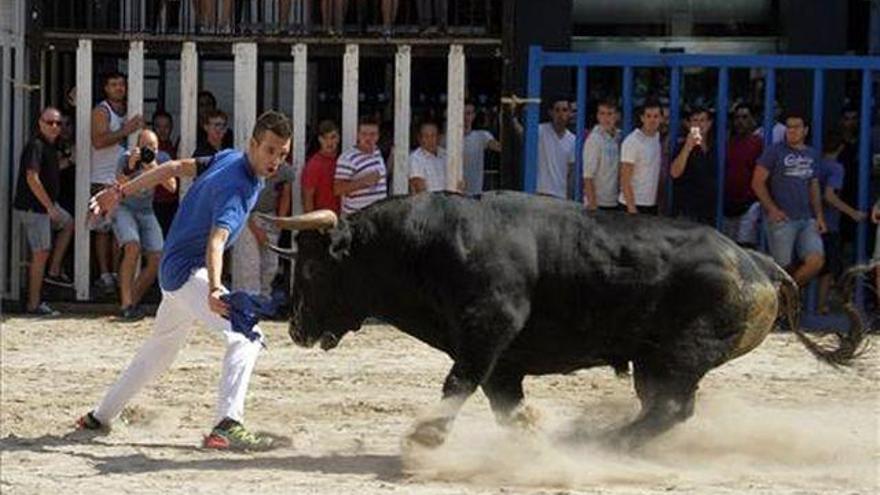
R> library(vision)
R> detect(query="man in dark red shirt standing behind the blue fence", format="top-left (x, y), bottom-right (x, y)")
top-left (724, 103), bottom-right (764, 247)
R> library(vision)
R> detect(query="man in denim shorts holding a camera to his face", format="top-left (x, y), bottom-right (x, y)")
top-left (113, 130), bottom-right (177, 321)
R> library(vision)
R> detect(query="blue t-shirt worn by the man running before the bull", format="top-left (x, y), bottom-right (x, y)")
top-left (159, 150), bottom-right (264, 291)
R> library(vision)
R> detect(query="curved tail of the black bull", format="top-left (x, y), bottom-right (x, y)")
top-left (749, 251), bottom-right (876, 366)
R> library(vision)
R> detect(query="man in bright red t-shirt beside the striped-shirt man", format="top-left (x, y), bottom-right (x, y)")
top-left (302, 120), bottom-right (339, 215)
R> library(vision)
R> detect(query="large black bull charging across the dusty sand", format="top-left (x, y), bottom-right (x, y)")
top-left (262, 192), bottom-right (862, 445)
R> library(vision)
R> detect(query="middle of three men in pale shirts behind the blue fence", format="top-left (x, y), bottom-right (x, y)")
top-left (583, 100), bottom-right (620, 210)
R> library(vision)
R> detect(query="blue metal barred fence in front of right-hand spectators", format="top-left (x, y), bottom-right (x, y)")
top-left (523, 46), bottom-right (880, 310)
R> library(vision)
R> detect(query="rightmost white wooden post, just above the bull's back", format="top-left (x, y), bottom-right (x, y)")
top-left (446, 45), bottom-right (465, 190)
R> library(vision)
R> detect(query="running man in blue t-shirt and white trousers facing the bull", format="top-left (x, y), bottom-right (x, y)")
top-left (77, 111), bottom-right (292, 450)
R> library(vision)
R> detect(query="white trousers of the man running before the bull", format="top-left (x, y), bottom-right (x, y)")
top-left (94, 268), bottom-right (262, 424)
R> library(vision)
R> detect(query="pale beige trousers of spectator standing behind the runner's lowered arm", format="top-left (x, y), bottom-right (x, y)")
top-left (232, 218), bottom-right (280, 296)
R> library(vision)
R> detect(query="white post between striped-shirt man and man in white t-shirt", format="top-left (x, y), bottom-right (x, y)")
top-left (391, 45), bottom-right (412, 194)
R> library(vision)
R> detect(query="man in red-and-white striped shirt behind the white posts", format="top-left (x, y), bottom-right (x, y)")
top-left (333, 117), bottom-right (388, 215)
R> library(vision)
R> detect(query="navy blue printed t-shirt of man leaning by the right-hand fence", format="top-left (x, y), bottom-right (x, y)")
top-left (758, 143), bottom-right (821, 220)
